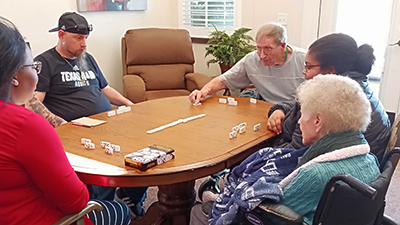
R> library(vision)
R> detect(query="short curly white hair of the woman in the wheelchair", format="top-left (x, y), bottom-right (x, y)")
top-left (297, 74), bottom-right (371, 134)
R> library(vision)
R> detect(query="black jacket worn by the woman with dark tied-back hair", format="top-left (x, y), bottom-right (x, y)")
top-left (268, 72), bottom-right (391, 161)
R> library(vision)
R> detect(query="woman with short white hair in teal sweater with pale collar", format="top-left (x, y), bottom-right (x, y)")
top-left (280, 75), bottom-right (380, 224)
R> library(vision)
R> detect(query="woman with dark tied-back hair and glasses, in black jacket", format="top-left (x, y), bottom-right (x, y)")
top-left (267, 33), bottom-right (391, 160)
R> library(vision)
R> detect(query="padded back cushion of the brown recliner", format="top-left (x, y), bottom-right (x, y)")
top-left (122, 28), bottom-right (194, 90)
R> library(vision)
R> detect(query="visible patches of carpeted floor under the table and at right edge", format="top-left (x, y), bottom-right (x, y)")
top-left (144, 164), bottom-right (400, 223)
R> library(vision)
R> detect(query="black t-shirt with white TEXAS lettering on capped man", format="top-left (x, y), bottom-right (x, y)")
top-left (35, 48), bottom-right (111, 121)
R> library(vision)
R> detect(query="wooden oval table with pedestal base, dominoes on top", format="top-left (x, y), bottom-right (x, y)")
top-left (56, 96), bottom-right (274, 225)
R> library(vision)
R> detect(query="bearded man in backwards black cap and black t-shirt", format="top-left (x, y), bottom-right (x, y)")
top-left (25, 12), bottom-right (147, 216)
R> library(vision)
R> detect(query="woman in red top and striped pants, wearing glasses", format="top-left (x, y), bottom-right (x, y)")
top-left (0, 17), bottom-right (130, 225)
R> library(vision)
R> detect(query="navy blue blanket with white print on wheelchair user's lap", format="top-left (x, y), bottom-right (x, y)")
top-left (209, 147), bottom-right (308, 225)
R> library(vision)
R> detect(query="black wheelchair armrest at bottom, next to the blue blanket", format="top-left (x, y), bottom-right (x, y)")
top-left (253, 201), bottom-right (304, 225)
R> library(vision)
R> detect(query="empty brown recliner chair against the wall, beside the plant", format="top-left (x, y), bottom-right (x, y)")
top-left (122, 28), bottom-right (211, 103)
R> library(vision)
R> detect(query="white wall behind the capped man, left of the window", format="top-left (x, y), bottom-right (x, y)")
top-left (0, 0), bottom-right (178, 93)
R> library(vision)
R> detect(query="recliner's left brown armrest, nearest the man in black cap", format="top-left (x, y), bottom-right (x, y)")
top-left (122, 74), bottom-right (147, 103)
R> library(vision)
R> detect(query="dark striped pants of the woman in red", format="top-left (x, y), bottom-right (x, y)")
top-left (86, 199), bottom-right (131, 225)
